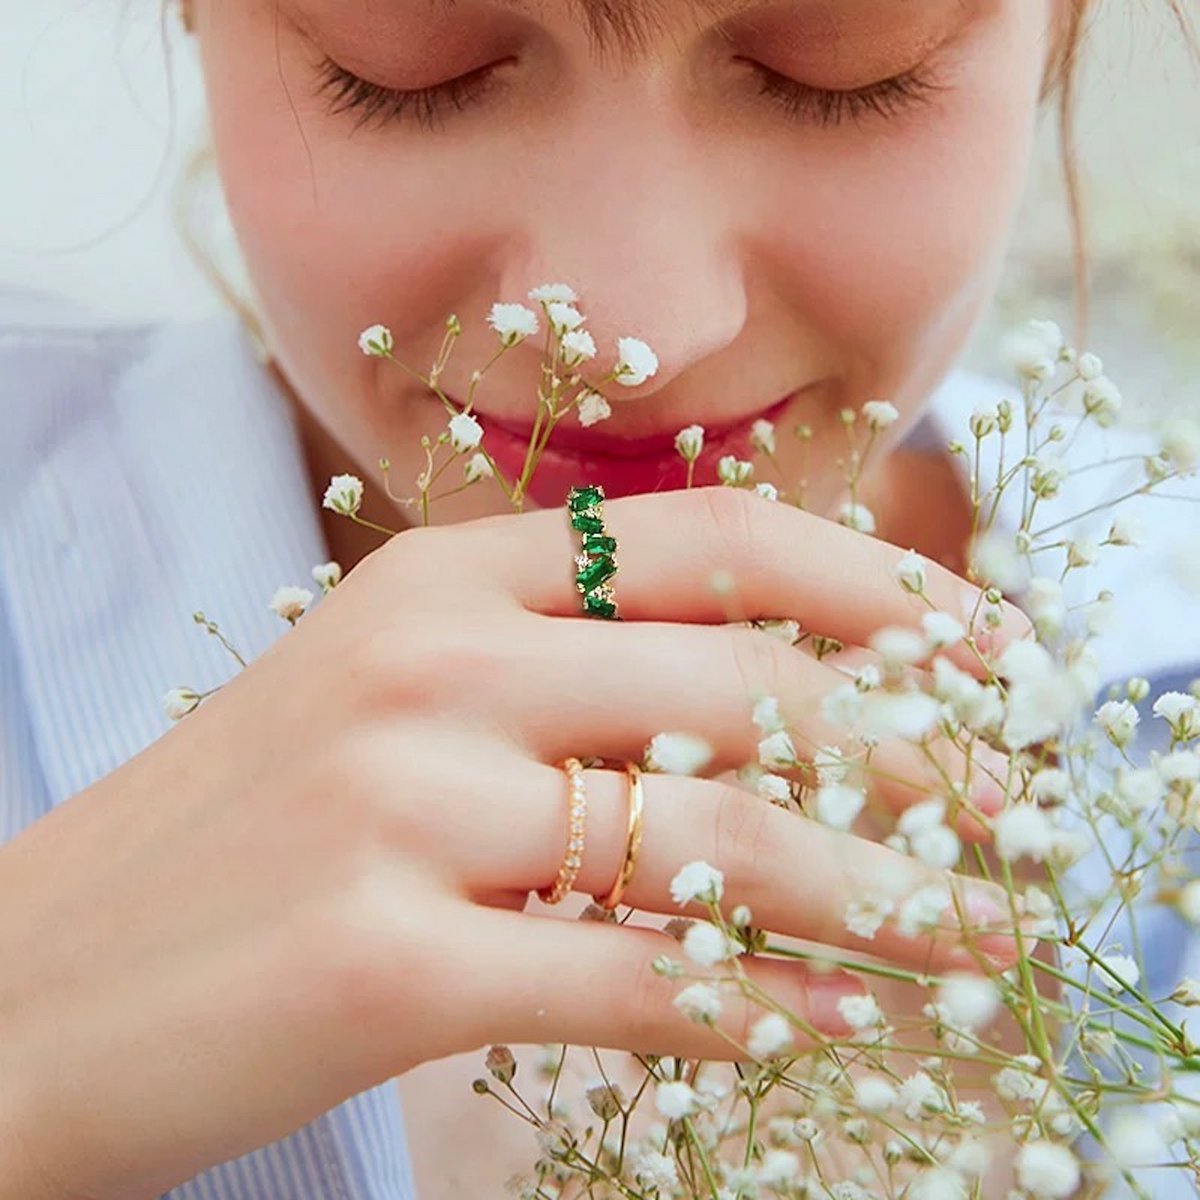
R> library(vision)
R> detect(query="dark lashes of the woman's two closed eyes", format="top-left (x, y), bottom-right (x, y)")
top-left (317, 58), bottom-right (940, 130)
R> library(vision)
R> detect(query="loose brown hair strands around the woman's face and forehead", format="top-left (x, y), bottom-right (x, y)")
top-left (163, 0), bottom-right (1200, 353)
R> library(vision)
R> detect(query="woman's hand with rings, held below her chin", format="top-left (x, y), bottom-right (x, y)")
top-left (0, 488), bottom-right (1027, 1200)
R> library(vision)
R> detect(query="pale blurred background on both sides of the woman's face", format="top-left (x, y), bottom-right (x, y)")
top-left (0, 0), bottom-right (1200, 410)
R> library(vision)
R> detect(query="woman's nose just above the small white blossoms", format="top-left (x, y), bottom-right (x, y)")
top-left (500, 113), bottom-right (748, 400)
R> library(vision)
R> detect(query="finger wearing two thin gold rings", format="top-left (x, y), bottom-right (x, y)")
top-left (460, 762), bottom-right (1016, 971)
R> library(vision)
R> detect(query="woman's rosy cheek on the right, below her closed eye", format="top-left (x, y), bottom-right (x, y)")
top-left (762, 15), bottom-right (1038, 379)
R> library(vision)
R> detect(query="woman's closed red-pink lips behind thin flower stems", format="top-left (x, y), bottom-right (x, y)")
top-left (463, 389), bottom-right (808, 508)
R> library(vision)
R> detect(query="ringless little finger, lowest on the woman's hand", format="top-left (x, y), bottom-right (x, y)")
top-left (458, 910), bottom-right (864, 1061)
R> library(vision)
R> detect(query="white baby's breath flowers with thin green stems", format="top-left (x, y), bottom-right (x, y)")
top-left (166, 284), bottom-right (1200, 1200)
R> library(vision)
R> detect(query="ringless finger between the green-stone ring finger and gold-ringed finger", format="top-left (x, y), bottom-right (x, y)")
top-left (487, 614), bottom-right (1004, 839)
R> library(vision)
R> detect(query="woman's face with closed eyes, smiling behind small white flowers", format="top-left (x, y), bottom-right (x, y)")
top-left (196, 0), bottom-right (1055, 521)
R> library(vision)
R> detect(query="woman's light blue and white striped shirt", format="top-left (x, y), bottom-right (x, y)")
top-left (0, 290), bottom-right (1200, 1200)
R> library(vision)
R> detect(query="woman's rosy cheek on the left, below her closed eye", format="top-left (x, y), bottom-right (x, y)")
top-left (196, 19), bottom-right (480, 366)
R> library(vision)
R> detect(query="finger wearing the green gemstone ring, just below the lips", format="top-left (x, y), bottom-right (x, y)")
top-left (472, 487), bottom-right (1032, 673)
